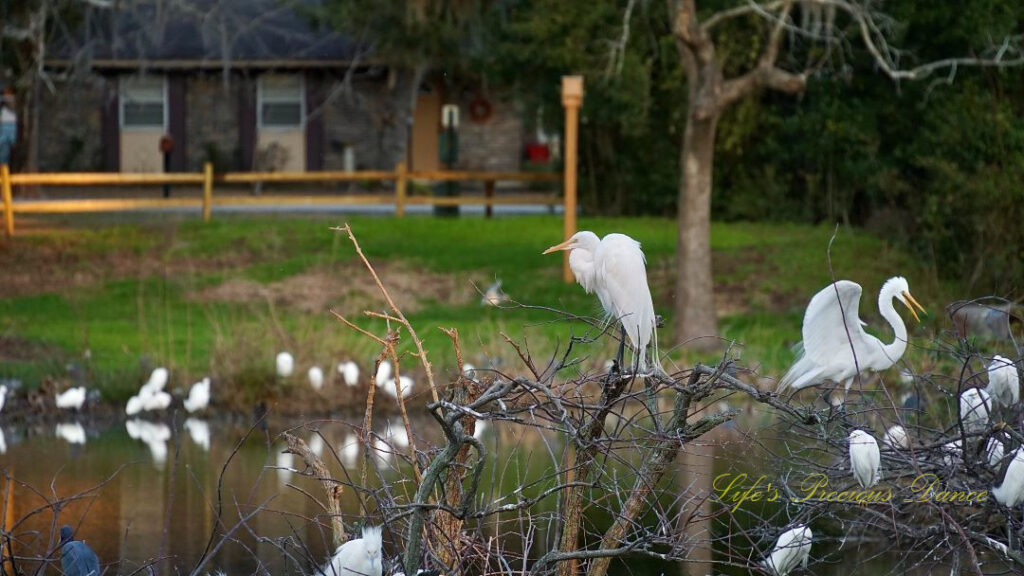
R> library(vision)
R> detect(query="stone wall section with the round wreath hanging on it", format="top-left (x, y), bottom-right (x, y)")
top-left (457, 97), bottom-right (523, 171)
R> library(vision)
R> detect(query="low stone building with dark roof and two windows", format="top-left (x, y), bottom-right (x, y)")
top-left (40, 0), bottom-right (525, 172)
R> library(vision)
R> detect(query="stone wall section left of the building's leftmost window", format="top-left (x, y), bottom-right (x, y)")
top-left (39, 76), bottom-right (110, 172)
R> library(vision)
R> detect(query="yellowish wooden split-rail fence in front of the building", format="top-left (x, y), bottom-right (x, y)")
top-left (0, 162), bottom-right (574, 237)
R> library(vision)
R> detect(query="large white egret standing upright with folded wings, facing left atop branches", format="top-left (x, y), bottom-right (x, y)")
top-left (544, 231), bottom-right (657, 371)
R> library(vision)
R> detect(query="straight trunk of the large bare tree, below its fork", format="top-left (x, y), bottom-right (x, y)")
top-left (675, 111), bottom-right (718, 349)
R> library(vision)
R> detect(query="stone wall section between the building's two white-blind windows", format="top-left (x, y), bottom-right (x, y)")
top-left (185, 74), bottom-right (244, 172)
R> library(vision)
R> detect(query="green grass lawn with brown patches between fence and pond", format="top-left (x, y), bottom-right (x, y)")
top-left (0, 216), bottom-right (945, 398)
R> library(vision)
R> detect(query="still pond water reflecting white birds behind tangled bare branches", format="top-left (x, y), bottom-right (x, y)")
top-left (0, 403), bottom-right (962, 576)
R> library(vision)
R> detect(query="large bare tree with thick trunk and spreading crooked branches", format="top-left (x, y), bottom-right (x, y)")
top-left (668, 0), bottom-right (1024, 347)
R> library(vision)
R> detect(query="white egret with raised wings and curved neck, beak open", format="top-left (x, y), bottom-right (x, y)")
top-left (778, 277), bottom-right (925, 392)
